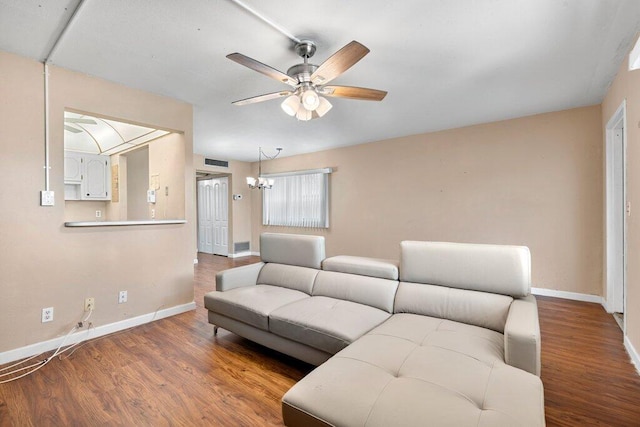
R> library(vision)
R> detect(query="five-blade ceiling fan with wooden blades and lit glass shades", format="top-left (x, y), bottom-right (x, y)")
top-left (227, 40), bottom-right (387, 121)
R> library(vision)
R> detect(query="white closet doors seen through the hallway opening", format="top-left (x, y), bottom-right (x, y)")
top-left (197, 176), bottom-right (229, 256)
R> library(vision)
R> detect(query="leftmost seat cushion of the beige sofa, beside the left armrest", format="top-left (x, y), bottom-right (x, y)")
top-left (204, 285), bottom-right (310, 331)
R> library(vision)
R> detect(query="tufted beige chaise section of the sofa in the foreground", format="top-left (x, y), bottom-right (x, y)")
top-left (283, 314), bottom-right (544, 427)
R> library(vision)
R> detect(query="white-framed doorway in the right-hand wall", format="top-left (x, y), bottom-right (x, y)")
top-left (605, 102), bottom-right (630, 332)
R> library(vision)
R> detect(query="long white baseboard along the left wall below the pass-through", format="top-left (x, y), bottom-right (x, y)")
top-left (0, 301), bottom-right (196, 365)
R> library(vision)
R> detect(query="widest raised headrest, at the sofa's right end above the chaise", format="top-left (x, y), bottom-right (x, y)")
top-left (400, 241), bottom-right (531, 298)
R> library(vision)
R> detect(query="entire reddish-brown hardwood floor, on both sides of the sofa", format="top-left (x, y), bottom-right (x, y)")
top-left (0, 254), bottom-right (640, 427)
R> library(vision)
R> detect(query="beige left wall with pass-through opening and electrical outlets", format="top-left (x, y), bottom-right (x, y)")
top-left (0, 52), bottom-right (195, 352)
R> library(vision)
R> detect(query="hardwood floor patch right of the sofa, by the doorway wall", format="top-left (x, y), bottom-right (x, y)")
top-left (537, 297), bottom-right (640, 426)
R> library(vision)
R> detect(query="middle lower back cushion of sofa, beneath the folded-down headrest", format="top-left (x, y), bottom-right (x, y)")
top-left (312, 271), bottom-right (398, 313)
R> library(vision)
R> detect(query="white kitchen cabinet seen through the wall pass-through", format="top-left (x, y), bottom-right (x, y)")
top-left (64, 151), bottom-right (111, 200)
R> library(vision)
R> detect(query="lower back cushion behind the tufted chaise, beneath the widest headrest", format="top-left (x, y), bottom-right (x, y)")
top-left (394, 282), bottom-right (513, 333)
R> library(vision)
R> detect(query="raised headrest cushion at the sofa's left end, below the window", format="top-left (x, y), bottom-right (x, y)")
top-left (260, 233), bottom-right (325, 269)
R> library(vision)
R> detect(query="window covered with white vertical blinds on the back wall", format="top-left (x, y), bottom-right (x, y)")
top-left (262, 169), bottom-right (331, 228)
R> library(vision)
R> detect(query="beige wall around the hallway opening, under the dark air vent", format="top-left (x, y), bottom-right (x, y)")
top-left (193, 154), bottom-right (251, 254)
